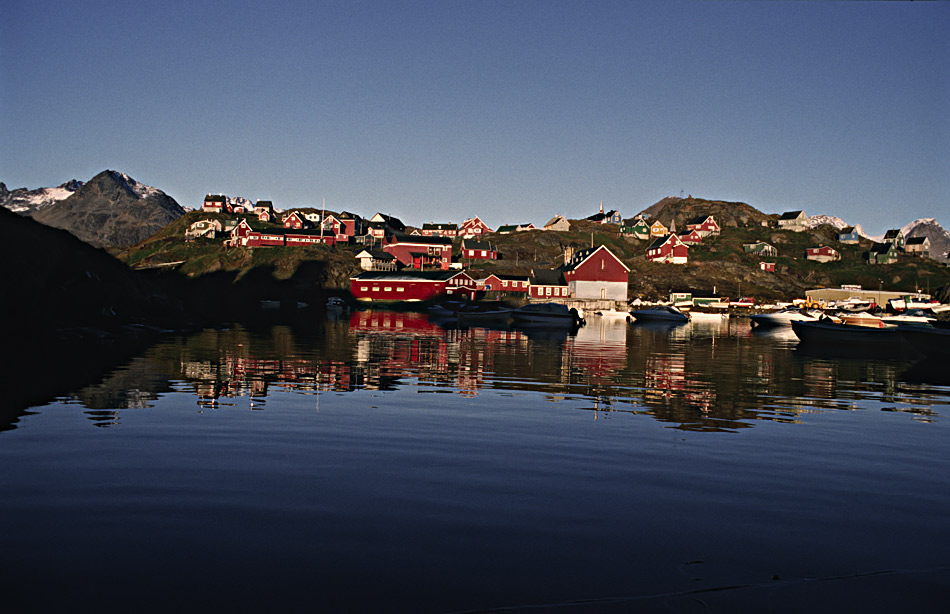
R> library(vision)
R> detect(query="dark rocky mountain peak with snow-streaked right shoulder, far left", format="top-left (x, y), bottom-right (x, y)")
top-left (32, 170), bottom-right (185, 247)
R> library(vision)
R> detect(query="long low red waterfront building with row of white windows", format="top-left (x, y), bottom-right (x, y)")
top-left (350, 270), bottom-right (476, 302)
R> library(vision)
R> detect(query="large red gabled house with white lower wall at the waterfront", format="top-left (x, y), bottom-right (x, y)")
top-left (561, 245), bottom-right (630, 301)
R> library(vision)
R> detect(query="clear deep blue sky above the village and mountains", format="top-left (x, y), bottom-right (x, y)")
top-left (0, 0), bottom-right (950, 234)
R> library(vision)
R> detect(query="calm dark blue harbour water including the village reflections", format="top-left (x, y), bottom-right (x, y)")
top-left (0, 312), bottom-right (950, 612)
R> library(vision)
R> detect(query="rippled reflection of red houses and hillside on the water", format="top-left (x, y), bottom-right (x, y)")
top-left (20, 311), bottom-right (946, 432)
